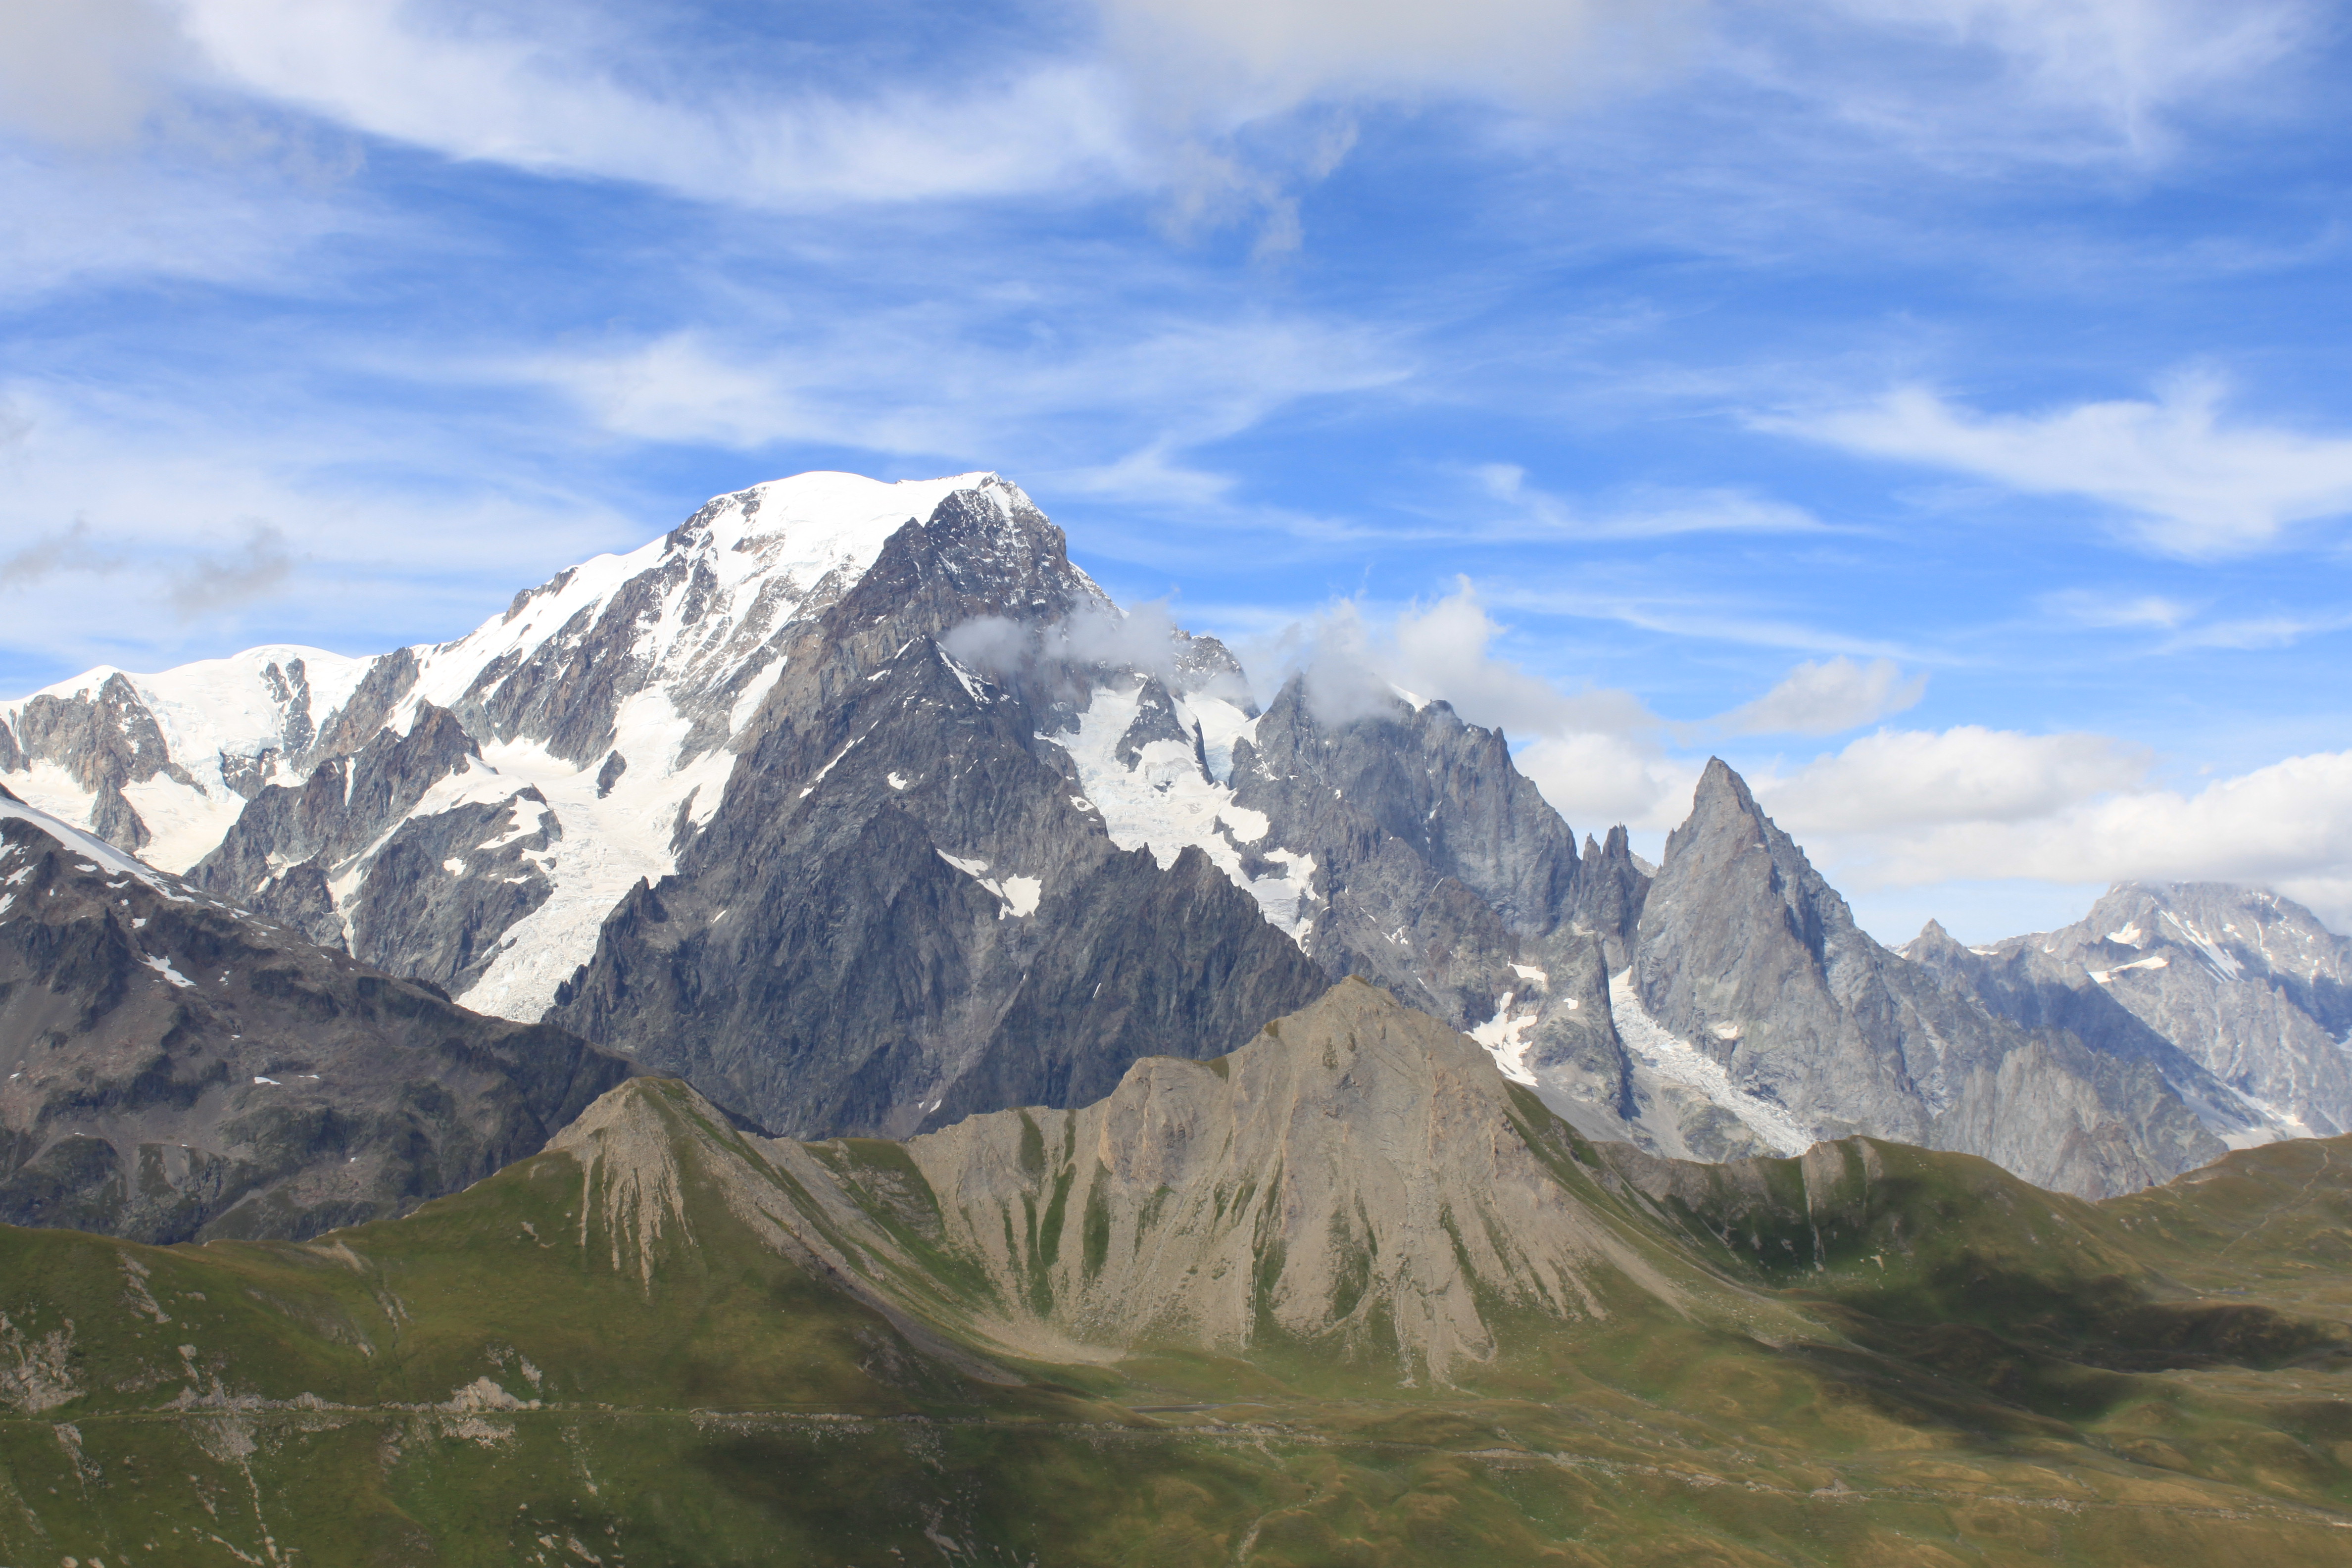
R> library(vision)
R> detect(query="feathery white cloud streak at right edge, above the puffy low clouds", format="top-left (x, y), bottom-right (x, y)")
top-left (1757, 376), bottom-right (2352, 559)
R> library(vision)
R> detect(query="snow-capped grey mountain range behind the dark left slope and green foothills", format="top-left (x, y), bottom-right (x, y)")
top-left (0, 475), bottom-right (2343, 1192)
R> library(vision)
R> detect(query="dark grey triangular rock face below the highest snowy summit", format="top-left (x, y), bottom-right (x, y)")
top-left (548, 487), bottom-right (1329, 1133)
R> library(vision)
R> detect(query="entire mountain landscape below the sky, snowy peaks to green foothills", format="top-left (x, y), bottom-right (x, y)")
top-left (0, 473), bottom-right (2352, 1568)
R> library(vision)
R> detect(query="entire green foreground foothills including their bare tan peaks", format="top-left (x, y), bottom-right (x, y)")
top-left (0, 980), bottom-right (2352, 1568)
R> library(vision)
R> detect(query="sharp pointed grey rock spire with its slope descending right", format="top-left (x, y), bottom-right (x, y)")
top-left (1618, 762), bottom-right (2246, 1197)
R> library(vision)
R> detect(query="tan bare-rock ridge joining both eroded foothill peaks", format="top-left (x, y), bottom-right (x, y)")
top-left (553, 978), bottom-right (1719, 1382)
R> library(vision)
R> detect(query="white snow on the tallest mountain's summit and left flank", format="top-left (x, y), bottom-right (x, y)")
top-left (0, 473), bottom-right (1077, 1020)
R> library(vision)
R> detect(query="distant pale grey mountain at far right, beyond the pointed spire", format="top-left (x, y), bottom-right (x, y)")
top-left (1903, 882), bottom-right (2352, 1142)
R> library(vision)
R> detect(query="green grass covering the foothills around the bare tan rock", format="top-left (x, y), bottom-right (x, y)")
top-left (0, 1100), bottom-right (2352, 1568)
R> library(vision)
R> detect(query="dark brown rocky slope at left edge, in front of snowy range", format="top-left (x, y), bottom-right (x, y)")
top-left (0, 794), bottom-right (631, 1241)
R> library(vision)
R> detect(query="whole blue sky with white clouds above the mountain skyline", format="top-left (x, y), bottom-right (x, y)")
top-left (0, 0), bottom-right (2352, 940)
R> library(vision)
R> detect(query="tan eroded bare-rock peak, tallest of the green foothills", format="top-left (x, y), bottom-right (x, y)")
top-left (889, 978), bottom-right (1677, 1377)
